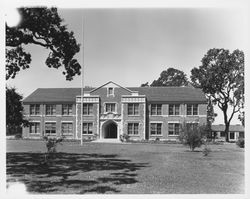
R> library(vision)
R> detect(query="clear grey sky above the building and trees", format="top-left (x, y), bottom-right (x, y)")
top-left (3, 2), bottom-right (248, 124)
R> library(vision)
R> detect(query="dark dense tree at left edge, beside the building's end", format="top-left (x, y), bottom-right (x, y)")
top-left (6, 87), bottom-right (28, 135)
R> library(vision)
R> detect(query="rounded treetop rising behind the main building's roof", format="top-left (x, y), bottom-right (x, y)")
top-left (150, 68), bottom-right (188, 86)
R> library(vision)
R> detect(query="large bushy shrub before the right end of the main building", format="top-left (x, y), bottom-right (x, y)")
top-left (179, 124), bottom-right (206, 151)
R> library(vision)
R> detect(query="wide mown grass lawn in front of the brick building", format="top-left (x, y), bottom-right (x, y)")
top-left (7, 140), bottom-right (245, 194)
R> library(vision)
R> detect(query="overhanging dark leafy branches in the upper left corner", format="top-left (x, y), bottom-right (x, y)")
top-left (6, 7), bottom-right (81, 80)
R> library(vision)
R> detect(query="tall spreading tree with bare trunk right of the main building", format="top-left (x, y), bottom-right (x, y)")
top-left (191, 48), bottom-right (244, 141)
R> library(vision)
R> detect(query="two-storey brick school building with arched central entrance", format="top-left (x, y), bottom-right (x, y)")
top-left (23, 82), bottom-right (207, 141)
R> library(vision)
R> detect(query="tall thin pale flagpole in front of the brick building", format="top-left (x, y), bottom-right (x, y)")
top-left (80, 16), bottom-right (84, 145)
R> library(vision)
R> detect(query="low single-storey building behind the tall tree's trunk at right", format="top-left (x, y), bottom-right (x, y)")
top-left (212, 124), bottom-right (245, 142)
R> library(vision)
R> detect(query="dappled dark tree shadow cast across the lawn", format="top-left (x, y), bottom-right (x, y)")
top-left (7, 153), bottom-right (147, 193)
